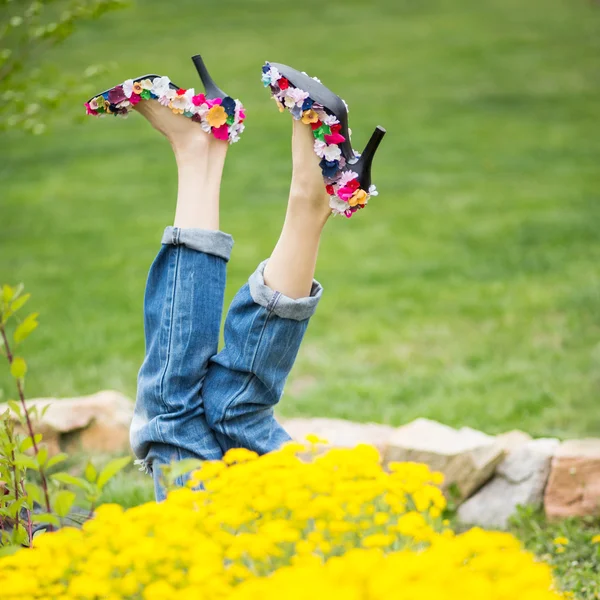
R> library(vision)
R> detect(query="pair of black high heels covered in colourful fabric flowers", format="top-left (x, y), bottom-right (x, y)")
top-left (85, 55), bottom-right (385, 217)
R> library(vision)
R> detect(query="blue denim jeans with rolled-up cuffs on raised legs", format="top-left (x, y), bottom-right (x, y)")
top-left (131, 227), bottom-right (322, 500)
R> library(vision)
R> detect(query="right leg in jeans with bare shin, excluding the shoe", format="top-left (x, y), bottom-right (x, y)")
top-left (202, 121), bottom-right (331, 454)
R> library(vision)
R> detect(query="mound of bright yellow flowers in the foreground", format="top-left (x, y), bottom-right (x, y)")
top-left (0, 444), bottom-right (563, 600)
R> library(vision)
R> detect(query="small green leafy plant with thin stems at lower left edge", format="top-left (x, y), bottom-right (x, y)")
top-left (0, 285), bottom-right (130, 554)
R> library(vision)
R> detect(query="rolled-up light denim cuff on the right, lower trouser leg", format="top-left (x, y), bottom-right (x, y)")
top-left (248, 260), bottom-right (323, 321)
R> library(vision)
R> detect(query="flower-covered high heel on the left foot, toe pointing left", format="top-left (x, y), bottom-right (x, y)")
top-left (85, 54), bottom-right (246, 144)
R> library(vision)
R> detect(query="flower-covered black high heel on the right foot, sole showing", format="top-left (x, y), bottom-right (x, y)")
top-left (262, 63), bottom-right (386, 217)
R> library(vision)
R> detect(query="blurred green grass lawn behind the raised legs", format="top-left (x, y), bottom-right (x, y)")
top-left (0, 0), bottom-right (600, 436)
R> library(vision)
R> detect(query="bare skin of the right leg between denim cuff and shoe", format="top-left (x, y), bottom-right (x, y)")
top-left (265, 121), bottom-right (331, 299)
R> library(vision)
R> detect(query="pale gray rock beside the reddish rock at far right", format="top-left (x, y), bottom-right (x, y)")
top-left (458, 438), bottom-right (559, 529)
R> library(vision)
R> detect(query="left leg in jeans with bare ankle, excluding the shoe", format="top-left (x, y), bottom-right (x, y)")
top-left (131, 102), bottom-right (233, 499)
